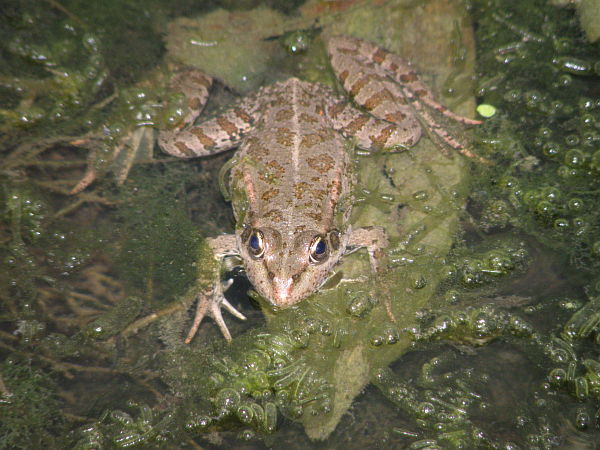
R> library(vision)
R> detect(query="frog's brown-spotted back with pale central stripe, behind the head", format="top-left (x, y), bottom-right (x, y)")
top-left (232, 78), bottom-right (351, 239)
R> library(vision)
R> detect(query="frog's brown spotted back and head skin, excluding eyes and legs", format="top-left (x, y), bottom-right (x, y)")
top-left (231, 78), bottom-right (352, 306)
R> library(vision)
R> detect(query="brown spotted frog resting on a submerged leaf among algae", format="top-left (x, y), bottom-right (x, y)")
top-left (158, 36), bottom-right (481, 343)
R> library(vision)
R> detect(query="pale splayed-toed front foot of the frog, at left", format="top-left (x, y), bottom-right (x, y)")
top-left (185, 280), bottom-right (246, 344)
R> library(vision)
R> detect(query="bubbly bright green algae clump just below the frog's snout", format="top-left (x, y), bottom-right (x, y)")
top-left (180, 328), bottom-right (333, 433)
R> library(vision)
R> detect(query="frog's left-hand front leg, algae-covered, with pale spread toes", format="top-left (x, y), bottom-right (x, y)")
top-left (185, 234), bottom-right (246, 344)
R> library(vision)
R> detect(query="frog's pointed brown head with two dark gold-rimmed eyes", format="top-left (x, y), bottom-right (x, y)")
top-left (239, 227), bottom-right (344, 307)
